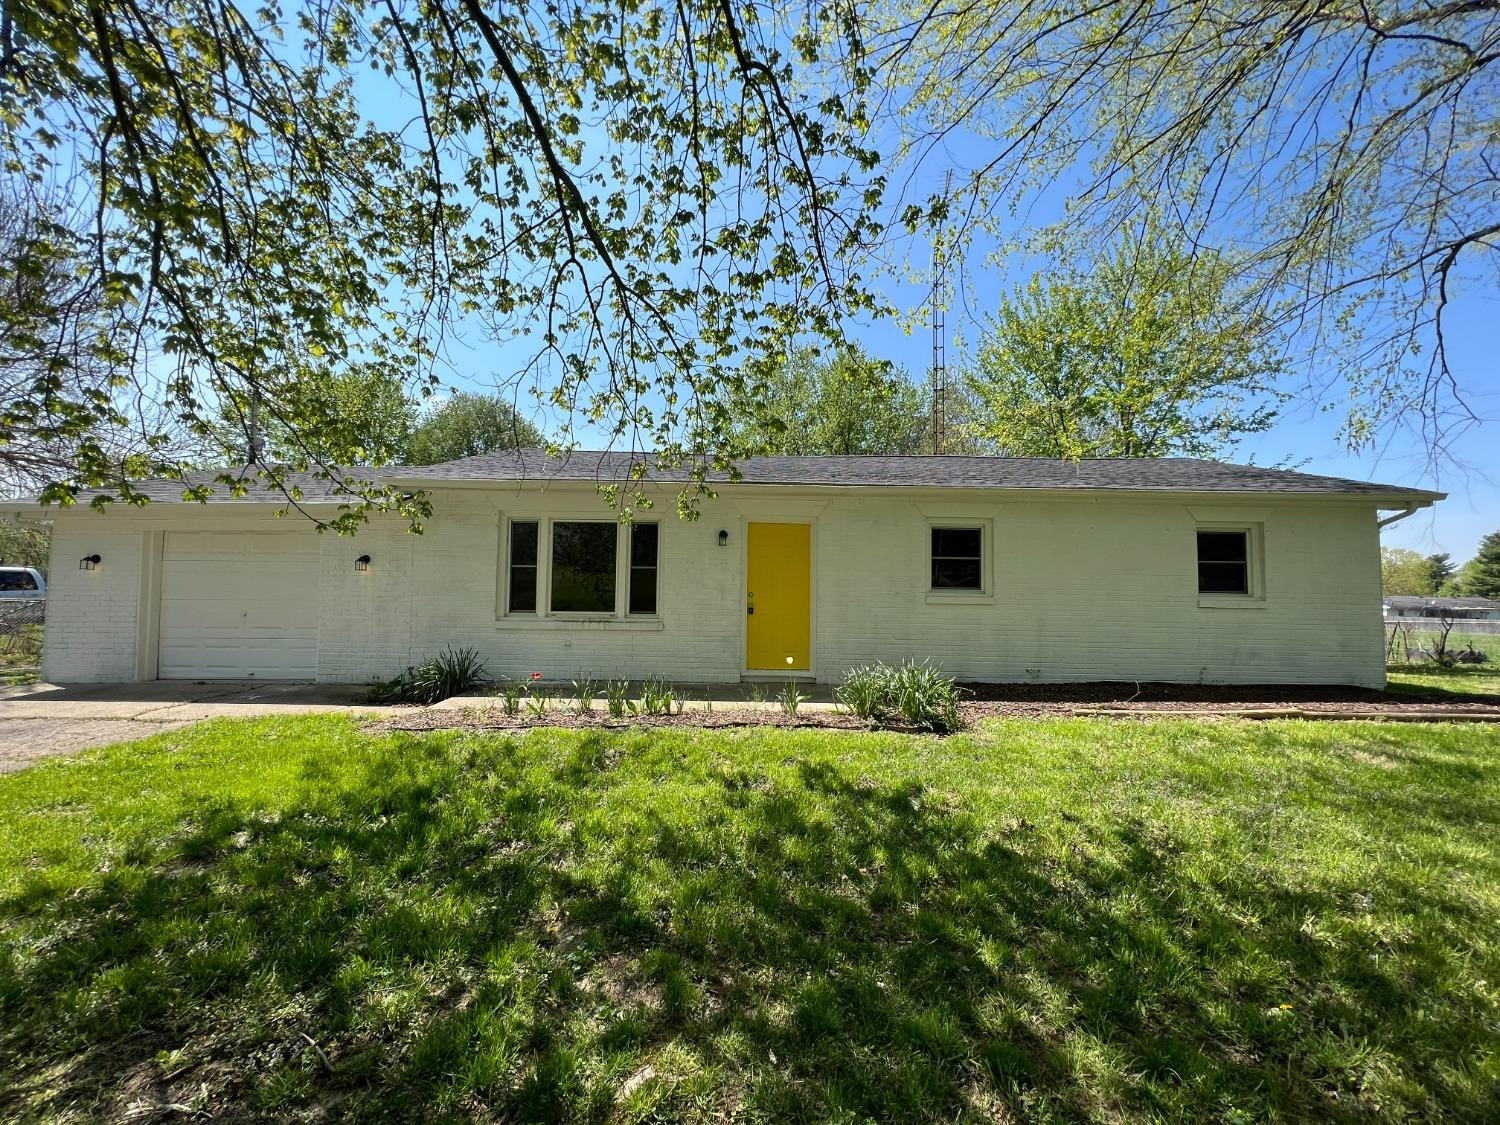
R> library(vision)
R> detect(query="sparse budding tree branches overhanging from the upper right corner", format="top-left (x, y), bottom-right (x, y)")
top-left (864, 0), bottom-right (1500, 453)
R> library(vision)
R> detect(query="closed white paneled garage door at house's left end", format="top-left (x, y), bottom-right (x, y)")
top-left (156, 531), bottom-right (318, 680)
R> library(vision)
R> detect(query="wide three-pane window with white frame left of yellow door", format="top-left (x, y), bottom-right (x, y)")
top-left (500, 519), bottom-right (660, 617)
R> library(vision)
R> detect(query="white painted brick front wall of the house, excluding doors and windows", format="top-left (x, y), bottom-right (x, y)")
top-left (45, 486), bottom-right (1385, 686)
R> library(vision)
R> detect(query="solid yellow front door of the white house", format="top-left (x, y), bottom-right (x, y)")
top-left (746, 524), bottom-right (813, 672)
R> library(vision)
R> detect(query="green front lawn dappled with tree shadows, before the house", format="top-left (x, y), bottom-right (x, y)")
top-left (0, 719), bottom-right (1500, 1122)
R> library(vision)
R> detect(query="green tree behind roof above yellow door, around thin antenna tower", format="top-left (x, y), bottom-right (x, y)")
top-left (734, 347), bottom-right (927, 455)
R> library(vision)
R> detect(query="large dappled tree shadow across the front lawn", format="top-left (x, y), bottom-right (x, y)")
top-left (0, 734), bottom-right (1497, 1121)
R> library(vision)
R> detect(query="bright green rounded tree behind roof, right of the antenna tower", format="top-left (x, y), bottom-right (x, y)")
top-left (968, 224), bottom-right (1280, 458)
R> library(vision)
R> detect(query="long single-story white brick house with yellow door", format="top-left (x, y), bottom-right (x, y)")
top-left (11, 452), bottom-right (1442, 687)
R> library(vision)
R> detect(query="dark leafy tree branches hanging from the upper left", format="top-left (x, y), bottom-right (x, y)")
top-left (0, 0), bottom-right (882, 530)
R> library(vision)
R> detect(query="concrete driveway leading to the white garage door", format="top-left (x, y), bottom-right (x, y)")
top-left (0, 680), bottom-right (372, 773)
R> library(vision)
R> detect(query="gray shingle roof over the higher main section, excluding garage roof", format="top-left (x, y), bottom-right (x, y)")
top-left (392, 450), bottom-right (1443, 500)
